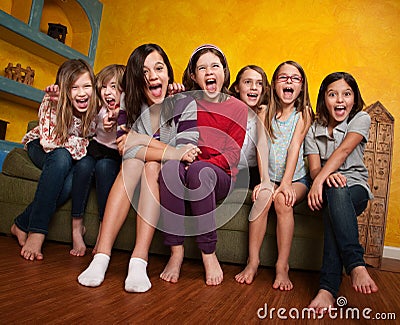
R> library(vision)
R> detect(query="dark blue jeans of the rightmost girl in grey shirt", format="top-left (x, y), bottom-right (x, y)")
top-left (320, 185), bottom-right (369, 297)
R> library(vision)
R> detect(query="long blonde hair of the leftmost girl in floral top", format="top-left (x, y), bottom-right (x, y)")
top-left (53, 59), bottom-right (97, 143)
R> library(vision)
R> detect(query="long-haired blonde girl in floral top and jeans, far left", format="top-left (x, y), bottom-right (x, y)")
top-left (11, 59), bottom-right (96, 261)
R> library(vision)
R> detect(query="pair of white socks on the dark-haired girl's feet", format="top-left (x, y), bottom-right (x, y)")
top-left (78, 253), bottom-right (151, 292)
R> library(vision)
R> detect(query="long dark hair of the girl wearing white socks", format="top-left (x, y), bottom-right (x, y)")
top-left (122, 43), bottom-right (174, 126)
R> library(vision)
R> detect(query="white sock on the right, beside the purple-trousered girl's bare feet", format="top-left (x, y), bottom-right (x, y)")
top-left (125, 257), bottom-right (151, 292)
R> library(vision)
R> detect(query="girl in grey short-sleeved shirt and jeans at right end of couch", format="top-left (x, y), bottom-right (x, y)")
top-left (305, 72), bottom-right (378, 313)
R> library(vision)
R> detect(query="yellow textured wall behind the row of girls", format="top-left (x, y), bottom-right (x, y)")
top-left (0, 0), bottom-right (400, 247)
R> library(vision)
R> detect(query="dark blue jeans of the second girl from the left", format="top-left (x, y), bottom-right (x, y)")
top-left (71, 156), bottom-right (120, 221)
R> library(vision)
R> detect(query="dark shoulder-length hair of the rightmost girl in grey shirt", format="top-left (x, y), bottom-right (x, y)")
top-left (316, 72), bottom-right (365, 126)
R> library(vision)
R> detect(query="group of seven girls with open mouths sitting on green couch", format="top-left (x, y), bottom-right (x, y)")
top-left (12, 44), bottom-right (378, 312)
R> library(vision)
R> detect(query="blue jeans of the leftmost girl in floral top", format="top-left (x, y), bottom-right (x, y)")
top-left (14, 139), bottom-right (74, 235)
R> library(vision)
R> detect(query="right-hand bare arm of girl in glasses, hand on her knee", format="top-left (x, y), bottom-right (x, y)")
top-left (273, 115), bottom-right (311, 206)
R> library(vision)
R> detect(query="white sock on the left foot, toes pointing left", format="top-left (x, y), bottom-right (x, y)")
top-left (78, 253), bottom-right (110, 287)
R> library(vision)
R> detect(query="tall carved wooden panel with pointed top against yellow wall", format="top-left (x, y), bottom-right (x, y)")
top-left (357, 102), bottom-right (394, 267)
